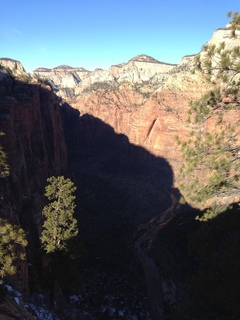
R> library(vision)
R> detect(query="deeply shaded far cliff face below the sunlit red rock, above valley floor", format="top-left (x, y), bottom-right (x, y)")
top-left (62, 104), bottom-right (173, 189)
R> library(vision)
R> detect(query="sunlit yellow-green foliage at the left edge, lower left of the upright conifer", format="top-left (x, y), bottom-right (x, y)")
top-left (0, 218), bottom-right (27, 278)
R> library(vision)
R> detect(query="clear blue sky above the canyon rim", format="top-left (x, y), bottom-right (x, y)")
top-left (0, 0), bottom-right (240, 72)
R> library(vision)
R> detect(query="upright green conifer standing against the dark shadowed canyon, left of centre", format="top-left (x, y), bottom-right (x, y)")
top-left (41, 176), bottom-right (78, 253)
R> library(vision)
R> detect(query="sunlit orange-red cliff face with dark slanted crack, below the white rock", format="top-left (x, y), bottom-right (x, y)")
top-left (69, 73), bottom-right (207, 184)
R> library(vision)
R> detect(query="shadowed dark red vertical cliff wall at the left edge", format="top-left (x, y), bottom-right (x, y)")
top-left (0, 63), bottom-right (67, 289)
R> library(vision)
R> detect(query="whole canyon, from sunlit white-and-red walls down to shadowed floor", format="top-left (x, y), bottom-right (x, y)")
top-left (0, 23), bottom-right (239, 320)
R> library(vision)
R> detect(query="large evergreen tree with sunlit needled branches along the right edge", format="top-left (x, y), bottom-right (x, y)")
top-left (177, 13), bottom-right (240, 221)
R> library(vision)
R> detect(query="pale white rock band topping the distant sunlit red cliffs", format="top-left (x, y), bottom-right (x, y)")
top-left (33, 55), bottom-right (175, 99)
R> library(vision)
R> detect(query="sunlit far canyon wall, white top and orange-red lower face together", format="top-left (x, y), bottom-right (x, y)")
top-left (33, 55), bottom-right (208, 184)
